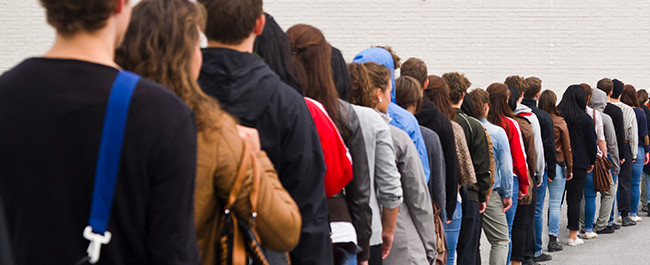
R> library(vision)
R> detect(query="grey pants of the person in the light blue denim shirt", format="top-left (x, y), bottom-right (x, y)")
top-left (483, 190), bottom-right (510, 265)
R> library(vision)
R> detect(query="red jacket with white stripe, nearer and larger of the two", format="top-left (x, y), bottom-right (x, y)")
top-left (305, 97), bottom-right (353, 198)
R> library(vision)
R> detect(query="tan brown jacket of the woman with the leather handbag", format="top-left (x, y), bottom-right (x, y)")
top-left (194, 112), bottom-right (302, 264)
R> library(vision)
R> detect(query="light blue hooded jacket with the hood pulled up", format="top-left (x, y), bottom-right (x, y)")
top-left (353, 47), bottom-right (431, 180)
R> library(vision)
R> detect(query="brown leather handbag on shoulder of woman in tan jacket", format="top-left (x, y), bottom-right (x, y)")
top-left (217, 142), bottom-right (269, 265)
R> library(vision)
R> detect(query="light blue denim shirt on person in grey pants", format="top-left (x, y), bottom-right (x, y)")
top-left (478, 118), bottom-right (513, 198)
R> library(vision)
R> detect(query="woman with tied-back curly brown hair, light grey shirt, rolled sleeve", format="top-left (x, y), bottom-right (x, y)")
top-left (348, 63), bottom-right (403, 265)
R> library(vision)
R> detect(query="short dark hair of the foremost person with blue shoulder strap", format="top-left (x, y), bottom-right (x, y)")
top-left (40, 0), bottom-right (121, 36)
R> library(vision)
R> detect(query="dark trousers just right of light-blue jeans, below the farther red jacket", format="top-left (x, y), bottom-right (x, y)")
top-left (510, 201), bottom-right (535, 261)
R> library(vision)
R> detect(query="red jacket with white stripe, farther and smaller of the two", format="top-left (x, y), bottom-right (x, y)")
top-left (501, 117), bottom-right (530, 194)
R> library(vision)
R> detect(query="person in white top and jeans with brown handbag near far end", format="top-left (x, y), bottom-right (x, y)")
top-left (580, 83), bottom-right (608, 239)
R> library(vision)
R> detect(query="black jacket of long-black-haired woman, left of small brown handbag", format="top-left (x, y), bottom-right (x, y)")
top-left (567, 112), bottom-right (598, 170)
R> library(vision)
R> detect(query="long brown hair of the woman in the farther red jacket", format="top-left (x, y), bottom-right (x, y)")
top-left (487, 83), bottom-right (515, 139)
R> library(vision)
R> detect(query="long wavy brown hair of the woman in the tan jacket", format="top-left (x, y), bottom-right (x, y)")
top-left (115, 0), bottom-right (219, 131)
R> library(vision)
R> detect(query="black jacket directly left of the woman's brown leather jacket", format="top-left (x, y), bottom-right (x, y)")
top-left (521, 98), bottom-right (556, 180)
